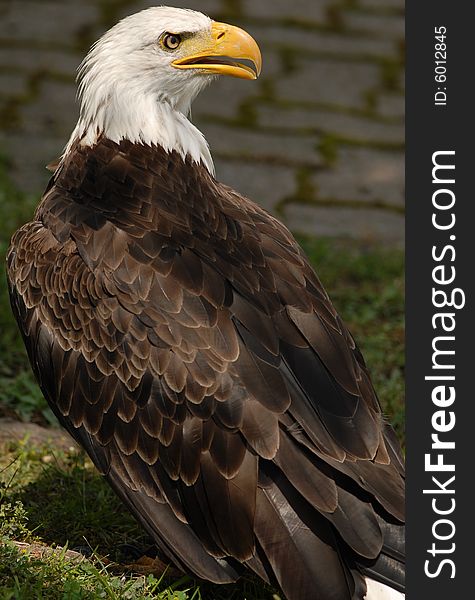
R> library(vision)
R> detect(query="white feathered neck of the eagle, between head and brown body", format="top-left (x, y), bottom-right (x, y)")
top-left (63, 88), bottom-right (214, 175)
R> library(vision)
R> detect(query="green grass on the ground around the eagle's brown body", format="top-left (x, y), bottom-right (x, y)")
top-left (0, 157), bottom-right (404, 600)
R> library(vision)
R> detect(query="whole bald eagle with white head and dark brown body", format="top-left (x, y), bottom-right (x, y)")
top-left (8, 7), bottom-right (404, 600)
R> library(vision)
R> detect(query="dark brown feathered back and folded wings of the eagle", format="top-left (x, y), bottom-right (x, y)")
top-left (9, 143), bottom-right (403, 593)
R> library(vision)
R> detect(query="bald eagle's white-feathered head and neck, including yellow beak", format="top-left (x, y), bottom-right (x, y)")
top-left (66, 6), bottom-right (262, 172)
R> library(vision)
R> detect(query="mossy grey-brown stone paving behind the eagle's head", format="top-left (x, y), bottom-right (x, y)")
top-left (0, 0), bottom-right (404, 245)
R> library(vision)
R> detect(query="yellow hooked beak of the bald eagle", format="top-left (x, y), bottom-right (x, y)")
top-left (172, 21), bottom-right (262, 79)
